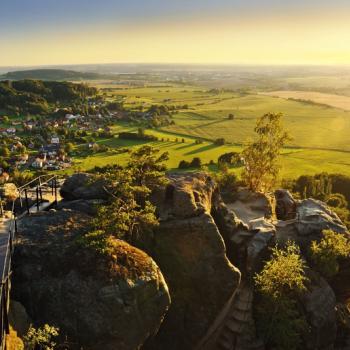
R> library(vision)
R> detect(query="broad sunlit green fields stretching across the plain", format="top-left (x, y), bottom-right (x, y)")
top-left (72, 85), bottom-right (350, 178)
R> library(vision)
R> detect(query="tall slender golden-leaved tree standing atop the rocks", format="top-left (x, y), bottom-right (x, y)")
top-left (242, 113), bottom-right (290, 191)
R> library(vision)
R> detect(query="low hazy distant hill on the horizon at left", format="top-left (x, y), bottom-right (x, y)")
top-left (0, 69), bottom-right (111, 81)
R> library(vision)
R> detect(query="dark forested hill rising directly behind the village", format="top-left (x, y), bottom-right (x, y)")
top-left (0, 79), bottom-right (97, 114)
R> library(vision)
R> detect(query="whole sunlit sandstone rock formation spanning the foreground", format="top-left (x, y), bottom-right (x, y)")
top-left (10, 174), bottom-right (348, 350)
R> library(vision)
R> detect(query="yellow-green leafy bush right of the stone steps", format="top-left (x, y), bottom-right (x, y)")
top-left (254, 242), bottom-right (307, 350)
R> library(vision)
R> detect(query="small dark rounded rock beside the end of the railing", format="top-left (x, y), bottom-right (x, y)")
top-left (60, 173), bottom-right (108, 200)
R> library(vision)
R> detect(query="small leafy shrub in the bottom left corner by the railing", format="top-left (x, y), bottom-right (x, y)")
top-left (23, 324), bottom-right (59, 350)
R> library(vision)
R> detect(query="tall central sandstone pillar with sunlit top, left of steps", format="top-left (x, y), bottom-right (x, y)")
top-left (145, 174), bottom-right (240, 350)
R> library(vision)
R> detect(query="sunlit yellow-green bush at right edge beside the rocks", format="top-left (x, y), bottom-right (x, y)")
top-left (310, 230), bottom-right (350, 278)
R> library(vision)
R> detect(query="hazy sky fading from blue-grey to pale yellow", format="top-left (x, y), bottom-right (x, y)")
top-left (0, 0), bottom-right (350, 66)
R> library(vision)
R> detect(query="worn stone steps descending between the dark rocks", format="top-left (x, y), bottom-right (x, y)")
top-left (217, 282), bottom-right (265, 350)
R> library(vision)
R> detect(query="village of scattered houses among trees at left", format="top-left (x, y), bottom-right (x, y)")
top-left (0, 109), bottom-right (120, 182)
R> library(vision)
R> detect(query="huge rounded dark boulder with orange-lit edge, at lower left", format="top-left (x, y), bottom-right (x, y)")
top-left (13, 210), bottom-right (170, 350)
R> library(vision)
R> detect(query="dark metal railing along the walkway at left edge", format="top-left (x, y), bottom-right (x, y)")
top-left (0, 175), bottom-right (58, 350)
